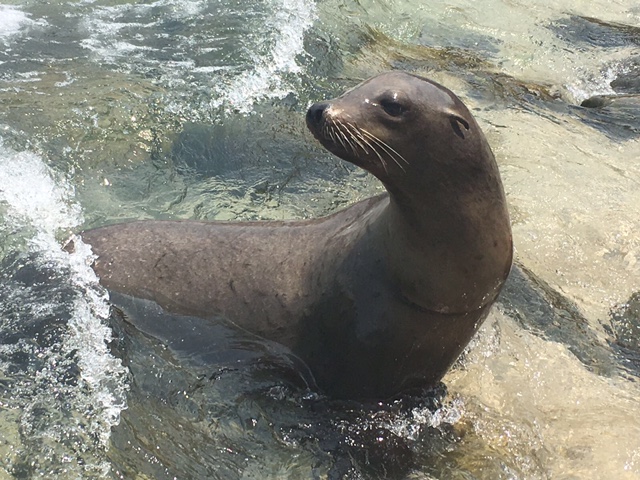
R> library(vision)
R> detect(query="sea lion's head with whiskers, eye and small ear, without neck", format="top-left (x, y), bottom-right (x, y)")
top-left (306, 71), bottom-right (493, 195)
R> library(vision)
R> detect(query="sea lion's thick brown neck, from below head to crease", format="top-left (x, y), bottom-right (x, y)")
top-left (380, 172), bottom-right (512, 313)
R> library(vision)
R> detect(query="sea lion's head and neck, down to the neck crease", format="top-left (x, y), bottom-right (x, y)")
top-left (306, 71), bottom-right (512, 314)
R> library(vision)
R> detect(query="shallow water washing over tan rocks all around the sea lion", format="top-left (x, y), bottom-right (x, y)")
top-left (0, 0), bottom-right (640, 479)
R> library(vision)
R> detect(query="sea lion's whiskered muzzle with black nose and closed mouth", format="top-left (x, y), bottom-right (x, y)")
top-left (306, 102), bottom-right (409, 175)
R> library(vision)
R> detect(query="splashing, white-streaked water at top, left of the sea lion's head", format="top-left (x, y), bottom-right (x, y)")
top-left (81, 0), bottom-right (316, 114)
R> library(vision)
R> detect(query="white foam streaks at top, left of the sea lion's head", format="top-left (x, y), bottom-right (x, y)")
top-left (81, 0), bottom-right (316, 113)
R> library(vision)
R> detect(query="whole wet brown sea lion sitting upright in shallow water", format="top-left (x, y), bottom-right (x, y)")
top-left (77, 72), bottom-right (512, 399)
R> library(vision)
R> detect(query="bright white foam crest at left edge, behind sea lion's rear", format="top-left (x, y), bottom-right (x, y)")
top-left (0, 142), bottom-right (127, 454)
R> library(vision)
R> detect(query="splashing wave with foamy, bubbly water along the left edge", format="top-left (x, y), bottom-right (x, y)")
top-left (0, 143), bottom-right (127, 475)
